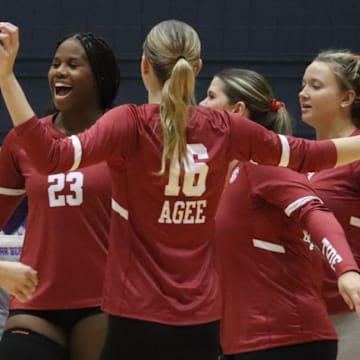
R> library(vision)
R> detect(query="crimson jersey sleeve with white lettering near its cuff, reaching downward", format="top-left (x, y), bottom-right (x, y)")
top-left (248, 165), bottom-right (359, 276)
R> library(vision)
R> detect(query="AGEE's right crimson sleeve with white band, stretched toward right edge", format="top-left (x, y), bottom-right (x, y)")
top-left (228, 113), bottom-right (337, 172)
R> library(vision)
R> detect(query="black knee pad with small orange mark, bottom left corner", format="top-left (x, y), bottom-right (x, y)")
top-left (0, 327), bottom-right (67, 360)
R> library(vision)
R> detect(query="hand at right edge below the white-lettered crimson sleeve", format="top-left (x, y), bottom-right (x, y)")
top-left (338, 271), bottom-right (360, 318)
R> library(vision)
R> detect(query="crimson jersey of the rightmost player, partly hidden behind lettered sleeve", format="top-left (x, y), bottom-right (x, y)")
top-left (309, 130), bottom-right (360, 314)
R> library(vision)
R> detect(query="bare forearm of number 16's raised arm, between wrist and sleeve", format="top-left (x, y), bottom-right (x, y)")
top-left (0, 73), bottom-right (34, 126)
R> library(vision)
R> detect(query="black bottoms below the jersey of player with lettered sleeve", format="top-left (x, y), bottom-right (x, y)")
top-left (222, 340), bottom-right (337, 360)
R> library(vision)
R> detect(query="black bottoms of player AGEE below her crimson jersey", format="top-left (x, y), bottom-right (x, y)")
top-left (101, 315), bottom-right (219, 360)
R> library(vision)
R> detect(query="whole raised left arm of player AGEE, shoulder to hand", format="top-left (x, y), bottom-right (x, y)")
top-left (0, 23), bottom-right (131, 174)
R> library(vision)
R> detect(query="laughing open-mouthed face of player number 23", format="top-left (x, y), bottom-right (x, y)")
top-left (48, 38), bottom-right (99, 111)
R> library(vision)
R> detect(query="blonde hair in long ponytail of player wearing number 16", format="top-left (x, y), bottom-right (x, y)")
top-left (144, 20), bottom-right (200, 175)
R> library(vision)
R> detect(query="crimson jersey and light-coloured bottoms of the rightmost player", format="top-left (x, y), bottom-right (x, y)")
top-left (308, 130), bottom-right (360, 360)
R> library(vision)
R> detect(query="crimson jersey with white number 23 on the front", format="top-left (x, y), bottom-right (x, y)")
top-left (0, 116), bottom-right (111, 309)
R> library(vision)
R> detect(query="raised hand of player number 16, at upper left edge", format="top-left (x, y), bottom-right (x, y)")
top-left (0, 22), bottom-right (19, 79)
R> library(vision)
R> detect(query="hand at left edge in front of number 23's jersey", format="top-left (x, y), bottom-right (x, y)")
top-left (0, 261), bottom-right (38, 302)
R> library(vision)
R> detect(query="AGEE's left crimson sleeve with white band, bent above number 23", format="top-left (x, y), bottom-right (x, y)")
top-left (15, 105), bottom-right (135, 174)
